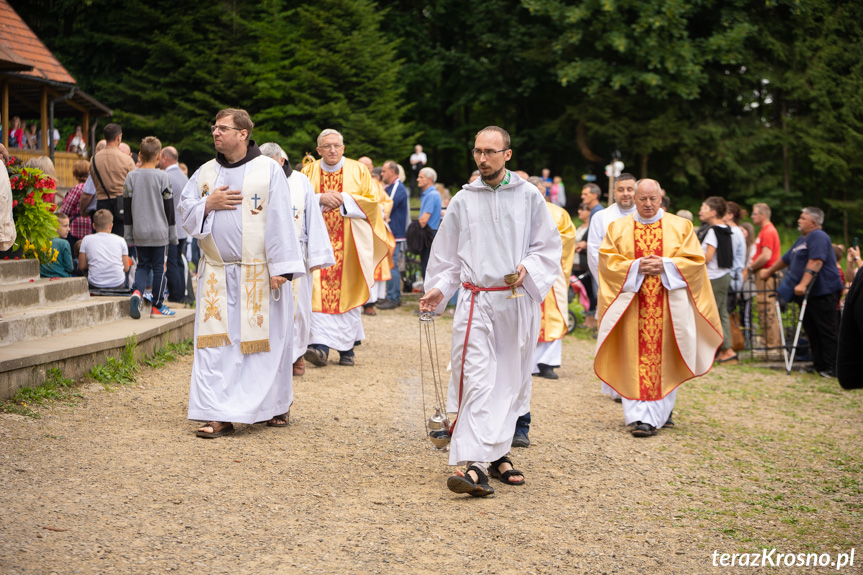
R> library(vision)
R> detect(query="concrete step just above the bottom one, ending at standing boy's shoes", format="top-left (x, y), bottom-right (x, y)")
top-left (0, 297), bottom-right (133, 347)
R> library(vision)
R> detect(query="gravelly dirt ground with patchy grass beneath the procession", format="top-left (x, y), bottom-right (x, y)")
top-left (0, 306), bottom-right (863, 574)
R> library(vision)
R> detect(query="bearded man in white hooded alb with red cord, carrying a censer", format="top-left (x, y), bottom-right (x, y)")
top-left (420, 126), bottom-right (561, 497)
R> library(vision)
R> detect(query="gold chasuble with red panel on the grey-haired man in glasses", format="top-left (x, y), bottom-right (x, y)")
top-left (303, 158), bottom-right (387, 314)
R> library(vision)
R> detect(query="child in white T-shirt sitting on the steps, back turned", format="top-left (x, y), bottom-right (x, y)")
top-left (78, 210), bottom-right (129, 289)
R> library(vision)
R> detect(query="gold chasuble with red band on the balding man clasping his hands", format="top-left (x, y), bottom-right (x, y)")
top-left (594, 214), bottom-right (722, 401)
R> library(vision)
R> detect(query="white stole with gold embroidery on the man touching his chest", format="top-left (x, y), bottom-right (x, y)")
top-left (197, 157), bottom-right (270, 354)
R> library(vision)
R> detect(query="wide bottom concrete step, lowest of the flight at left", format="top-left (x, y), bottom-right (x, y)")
top-left (0, 306), bottom-right (195, 399)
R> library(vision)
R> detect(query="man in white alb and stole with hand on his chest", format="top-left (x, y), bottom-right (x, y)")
top-left (178, 109), bottom-right (305, 438)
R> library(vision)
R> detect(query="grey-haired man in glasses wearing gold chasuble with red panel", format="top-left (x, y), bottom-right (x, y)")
top-left (303, 129), bottom-right (387, 367)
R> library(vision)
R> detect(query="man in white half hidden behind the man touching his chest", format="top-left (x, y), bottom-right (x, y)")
top-left (261, 142), bottom-right (335, 377)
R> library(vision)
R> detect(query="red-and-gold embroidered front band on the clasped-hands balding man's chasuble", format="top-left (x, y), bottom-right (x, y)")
top-left (635, 220), bottom-right (665, 401)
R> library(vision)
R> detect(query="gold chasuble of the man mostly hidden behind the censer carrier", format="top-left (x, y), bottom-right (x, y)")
top-left (539, 202), bottom-right (575, 342)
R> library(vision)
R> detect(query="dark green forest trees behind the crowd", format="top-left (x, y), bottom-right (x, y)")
top-left (11, 0), bottom-right (863, 245)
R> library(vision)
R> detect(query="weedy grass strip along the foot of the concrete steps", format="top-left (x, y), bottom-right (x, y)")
top-left (0, 336), bottom-right (193, 419)
